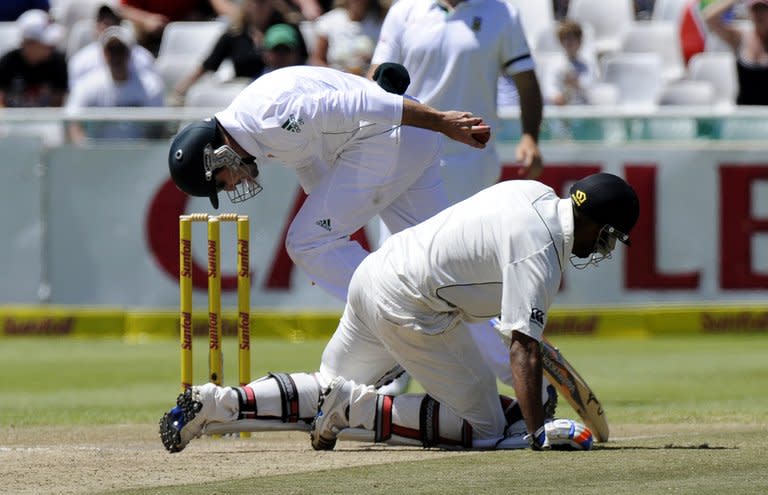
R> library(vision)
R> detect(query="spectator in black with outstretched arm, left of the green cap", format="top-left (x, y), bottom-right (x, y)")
top-left (174, 0), bottom-right (294, 101)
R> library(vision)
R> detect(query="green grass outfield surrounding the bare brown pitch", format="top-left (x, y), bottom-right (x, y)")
top-left (0, 335), bottom-right (768, 495)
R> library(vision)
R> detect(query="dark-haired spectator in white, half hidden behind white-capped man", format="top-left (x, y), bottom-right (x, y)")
top-left (67, 4), bottom-right (155, 87)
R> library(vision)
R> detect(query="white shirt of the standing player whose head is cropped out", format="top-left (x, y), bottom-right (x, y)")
top-left (372, 0), bottom-right (544, 154)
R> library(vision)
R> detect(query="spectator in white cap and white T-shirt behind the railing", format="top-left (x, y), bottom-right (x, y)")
top-left (66, 26), bottom-right (165, 143)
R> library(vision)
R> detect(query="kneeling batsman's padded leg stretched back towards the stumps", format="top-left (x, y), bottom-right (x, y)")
top-left (160, 258), bottom-right (402, 452)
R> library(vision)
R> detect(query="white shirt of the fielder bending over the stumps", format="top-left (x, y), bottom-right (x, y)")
top-left (216, 66), bottom-right (403, 168)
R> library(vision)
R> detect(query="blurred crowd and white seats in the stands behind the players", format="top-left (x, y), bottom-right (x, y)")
top-left (0, 0), bottom-right (768, 142)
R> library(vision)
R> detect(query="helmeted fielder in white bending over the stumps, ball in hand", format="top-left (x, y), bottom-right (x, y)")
top-left (168, 66), bottom-right (490, 300)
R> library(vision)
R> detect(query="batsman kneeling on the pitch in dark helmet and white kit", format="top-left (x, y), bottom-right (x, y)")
top-left (160, 173), bottom-right (639, 452)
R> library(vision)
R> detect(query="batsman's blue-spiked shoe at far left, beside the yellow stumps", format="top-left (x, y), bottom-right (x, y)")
top-left (160, 383), bottom-right (216, 454)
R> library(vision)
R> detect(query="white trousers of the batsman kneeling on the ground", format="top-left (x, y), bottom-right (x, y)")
top-left (320, 257), bottom-right (506, 444)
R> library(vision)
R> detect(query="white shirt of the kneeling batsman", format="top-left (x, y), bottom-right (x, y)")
top-left (365, 180), bottom-right (573, 340)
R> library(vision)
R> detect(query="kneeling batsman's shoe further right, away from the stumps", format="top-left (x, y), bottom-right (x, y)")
top-left (309, 376), bottom-right (352, 450)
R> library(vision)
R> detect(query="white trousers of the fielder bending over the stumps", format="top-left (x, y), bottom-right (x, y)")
top-left (286, 126), bottom-right (448, 301)
